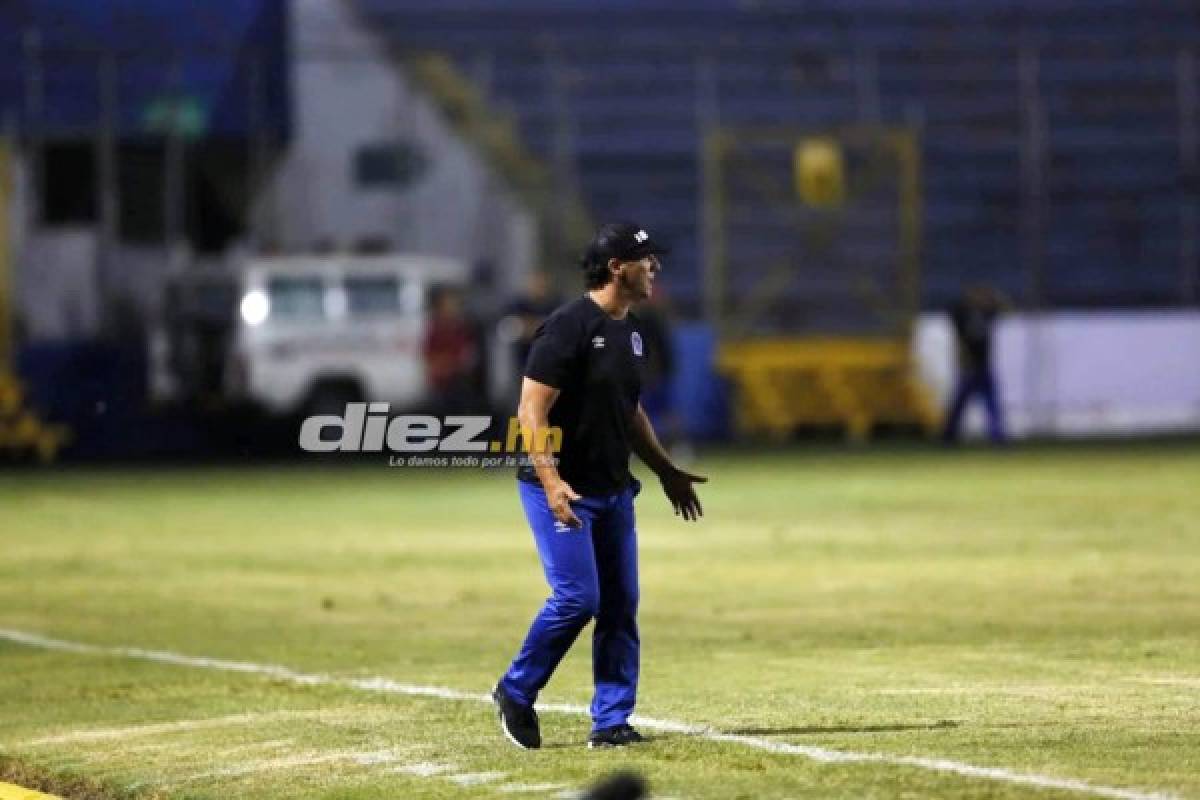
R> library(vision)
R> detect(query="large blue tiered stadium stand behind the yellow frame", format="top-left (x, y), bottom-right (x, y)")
top-left (358, 0), bottom-right (1200, 313)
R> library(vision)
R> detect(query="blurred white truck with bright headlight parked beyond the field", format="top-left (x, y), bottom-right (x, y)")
top-left (150, 255), bottom-right (468, 414)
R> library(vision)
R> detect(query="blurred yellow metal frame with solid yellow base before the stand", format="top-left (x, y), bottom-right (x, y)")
top-left (702, 125), bottom-right (940, 440)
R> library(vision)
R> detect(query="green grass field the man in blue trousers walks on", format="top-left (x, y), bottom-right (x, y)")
top-left (0, 445), bottom-right (1200, 800)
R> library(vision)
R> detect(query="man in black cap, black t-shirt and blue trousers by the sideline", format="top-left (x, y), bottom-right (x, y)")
top-left (492, 223), bottom-right (707, 750)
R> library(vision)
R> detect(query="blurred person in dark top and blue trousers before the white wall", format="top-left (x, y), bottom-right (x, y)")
top-left (942, 285), bottom-right (1009, 445)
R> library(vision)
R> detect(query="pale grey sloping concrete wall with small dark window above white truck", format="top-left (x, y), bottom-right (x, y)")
top-left (257, 0), bottom-right (536, 293)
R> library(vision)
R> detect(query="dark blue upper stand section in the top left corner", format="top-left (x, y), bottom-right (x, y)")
top-left (0, 0), bottom-right (289, 139)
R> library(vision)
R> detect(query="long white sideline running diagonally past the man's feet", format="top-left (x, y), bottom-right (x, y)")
top-left (0, 628), bottom-right (1174, 800)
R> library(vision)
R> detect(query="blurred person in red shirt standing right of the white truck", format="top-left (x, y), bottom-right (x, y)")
top-left (422, 287), bottom-right (480, 415)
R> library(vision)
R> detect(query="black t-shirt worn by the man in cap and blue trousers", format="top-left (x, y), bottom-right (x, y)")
top-left (517, 295), bottom-right (646, 494)
